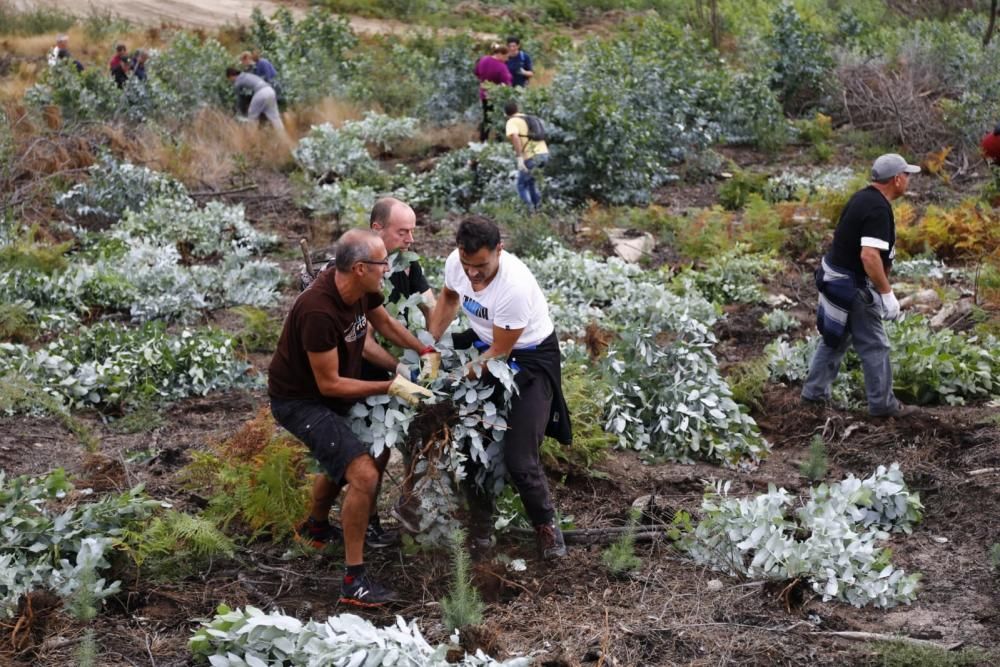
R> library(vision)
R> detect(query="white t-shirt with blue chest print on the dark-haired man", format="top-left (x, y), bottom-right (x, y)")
top-left (444, 249), bottom-right (554, 350)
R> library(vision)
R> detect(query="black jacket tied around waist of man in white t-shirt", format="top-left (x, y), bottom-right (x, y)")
top-left (452, 329), bottom-right (573, 445)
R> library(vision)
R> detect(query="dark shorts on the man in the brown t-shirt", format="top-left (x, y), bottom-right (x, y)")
top-left (271, 396), bottom-right (368, 486)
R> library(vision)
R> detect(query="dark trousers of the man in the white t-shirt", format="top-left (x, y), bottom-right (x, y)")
top-left (466, 374), bottom-right (555, 526)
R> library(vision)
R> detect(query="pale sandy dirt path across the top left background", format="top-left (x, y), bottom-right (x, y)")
top-left (7, 0), bottom-right (496, 40)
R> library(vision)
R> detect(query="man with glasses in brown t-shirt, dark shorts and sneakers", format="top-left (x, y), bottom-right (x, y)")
top-left (268, 229), bottom-right (437, 607)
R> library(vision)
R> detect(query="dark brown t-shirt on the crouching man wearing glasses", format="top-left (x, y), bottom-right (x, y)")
top-left (267, 269), bottom-right (382, 414)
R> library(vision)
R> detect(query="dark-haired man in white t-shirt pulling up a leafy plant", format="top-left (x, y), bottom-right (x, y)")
top-left (428, 215), bottom-right (572, 559)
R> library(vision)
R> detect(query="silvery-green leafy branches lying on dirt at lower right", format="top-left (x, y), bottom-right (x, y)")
top-left (680, 463), bottom-right (922, 607)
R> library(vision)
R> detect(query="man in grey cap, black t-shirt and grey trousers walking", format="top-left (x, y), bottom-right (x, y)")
top-left (802, 153), bottom-right (920, 417)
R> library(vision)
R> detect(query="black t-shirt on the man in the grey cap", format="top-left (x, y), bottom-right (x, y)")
top-left (827, 185), bottom-right (896, 284)
